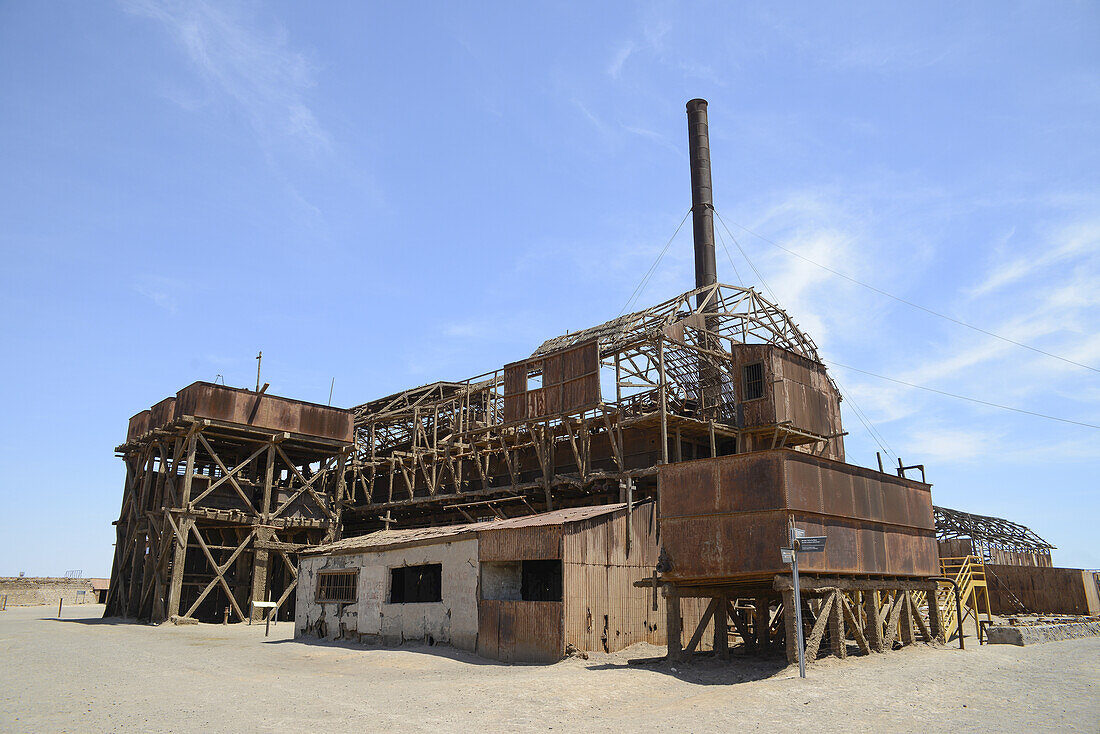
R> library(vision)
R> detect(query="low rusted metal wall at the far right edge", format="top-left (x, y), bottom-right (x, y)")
top-left (986, 563), bottom-right (1100, 614)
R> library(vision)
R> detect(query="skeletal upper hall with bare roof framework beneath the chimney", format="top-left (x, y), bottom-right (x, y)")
top-left (345, 284), bottom-right (843, 530)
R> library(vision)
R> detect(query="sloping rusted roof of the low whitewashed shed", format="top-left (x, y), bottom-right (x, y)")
top-left (300, 502), bottom-right (626, 556)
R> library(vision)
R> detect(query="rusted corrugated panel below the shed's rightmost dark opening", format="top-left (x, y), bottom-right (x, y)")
top-left (477, 599), bottom-right (565, 662)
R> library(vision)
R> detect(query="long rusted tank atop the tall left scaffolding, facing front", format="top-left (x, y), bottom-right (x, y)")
top-left (175, 382), bottom-right (354, 443)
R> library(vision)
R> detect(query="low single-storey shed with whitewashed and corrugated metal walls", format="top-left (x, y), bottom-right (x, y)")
top-left (295, 503), bottom-right (701, 662)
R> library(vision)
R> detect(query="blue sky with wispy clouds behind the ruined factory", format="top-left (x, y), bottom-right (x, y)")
top-left (0, 2), bottom-right (1100, 576)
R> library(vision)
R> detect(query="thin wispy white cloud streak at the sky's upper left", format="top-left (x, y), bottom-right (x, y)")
top-left (123, 0), bottom-right (332, 155)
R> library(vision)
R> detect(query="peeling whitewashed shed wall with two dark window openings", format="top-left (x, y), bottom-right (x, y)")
top-left (295, 538), bottom-right (479, 650)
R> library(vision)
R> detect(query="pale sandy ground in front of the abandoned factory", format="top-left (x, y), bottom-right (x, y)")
top-left (0, 605), bottom-right (1100, 733)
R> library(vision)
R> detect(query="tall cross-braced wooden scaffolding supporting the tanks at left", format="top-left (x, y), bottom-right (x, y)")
top-left (105, 411), bottom-right (350, 622)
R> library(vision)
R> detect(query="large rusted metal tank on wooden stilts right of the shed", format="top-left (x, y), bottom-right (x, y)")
top-left (659, 449), bottom-right (939, 583)
